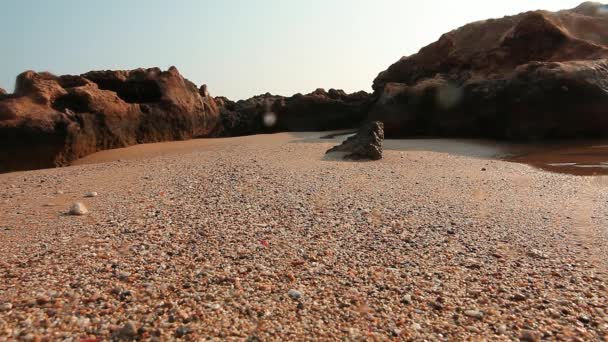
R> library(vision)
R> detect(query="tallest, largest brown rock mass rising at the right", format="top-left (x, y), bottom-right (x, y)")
top-left (369, 2), bottom-right (608, 140)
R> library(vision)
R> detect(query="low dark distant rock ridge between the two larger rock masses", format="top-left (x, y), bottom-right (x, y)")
top-left (216, 89), bottom-right (371, 136)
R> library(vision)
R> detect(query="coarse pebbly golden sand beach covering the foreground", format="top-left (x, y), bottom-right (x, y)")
top-left (0, 133), bottom-right (608, 341)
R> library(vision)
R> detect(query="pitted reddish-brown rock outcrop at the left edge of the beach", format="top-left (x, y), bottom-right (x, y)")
top-left (0, 67), bottom-right (220, 172)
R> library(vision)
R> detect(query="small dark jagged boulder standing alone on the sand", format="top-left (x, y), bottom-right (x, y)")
top-left (326, 121), bottom-right (384, 160)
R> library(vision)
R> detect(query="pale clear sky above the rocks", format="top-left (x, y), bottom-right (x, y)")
top-left (0, 0), bottom-right (582, 99)
